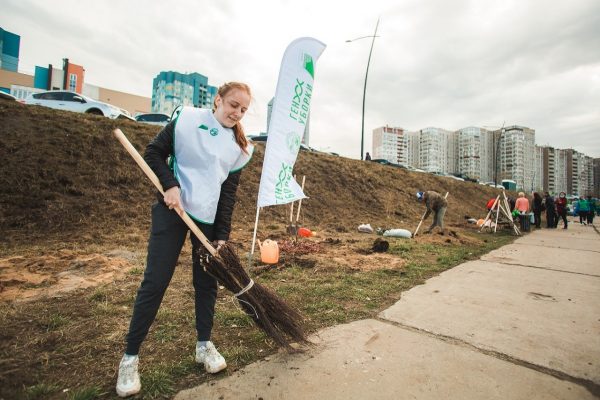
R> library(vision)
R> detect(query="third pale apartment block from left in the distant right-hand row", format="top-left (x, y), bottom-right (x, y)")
top-left (456, 126), bottom-right (494, 182)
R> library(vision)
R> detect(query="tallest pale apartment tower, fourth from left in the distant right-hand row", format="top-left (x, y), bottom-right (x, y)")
top-left (494, 125), bottom-right (535, 189)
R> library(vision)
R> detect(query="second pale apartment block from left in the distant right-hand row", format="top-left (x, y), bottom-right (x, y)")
top-left (419, 127), bottom-right (456, 174)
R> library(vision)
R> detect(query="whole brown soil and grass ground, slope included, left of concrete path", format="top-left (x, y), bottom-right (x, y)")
top-left (0, 101), bottom-right (512, 399)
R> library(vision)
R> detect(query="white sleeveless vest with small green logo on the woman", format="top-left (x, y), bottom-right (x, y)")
top-left (173, 107), bottom-right (254, 224)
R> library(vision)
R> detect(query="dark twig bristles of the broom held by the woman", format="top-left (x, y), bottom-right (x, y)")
top-left (205, 243), bottom-right (310, 351)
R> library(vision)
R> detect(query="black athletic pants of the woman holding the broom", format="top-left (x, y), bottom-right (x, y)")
top-left (125, 203), bottom-right (217, 355)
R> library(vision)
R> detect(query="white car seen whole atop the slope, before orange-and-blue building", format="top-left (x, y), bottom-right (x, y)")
top-left (24, 90), bottom-right (133, 119)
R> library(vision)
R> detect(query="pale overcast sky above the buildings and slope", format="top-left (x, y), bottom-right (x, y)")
top-left (0, 0), bottom-right (600, 158)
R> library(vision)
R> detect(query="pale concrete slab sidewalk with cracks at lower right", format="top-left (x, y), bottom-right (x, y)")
top-left (176, 224), bottom-right (600, 400)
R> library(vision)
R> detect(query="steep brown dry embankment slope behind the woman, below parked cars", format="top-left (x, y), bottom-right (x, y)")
top-left (0, 101), bottom-right (506, 245)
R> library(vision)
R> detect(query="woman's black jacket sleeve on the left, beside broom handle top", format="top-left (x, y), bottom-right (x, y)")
top-left (144, 121), bottom-right (179, 192)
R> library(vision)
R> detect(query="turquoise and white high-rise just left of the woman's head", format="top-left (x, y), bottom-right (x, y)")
top-left (152, 71), bottom-right (217, 115)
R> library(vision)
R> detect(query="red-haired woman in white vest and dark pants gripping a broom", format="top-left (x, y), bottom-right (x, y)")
top-left (116, 82), bottom-right (253, 397)
